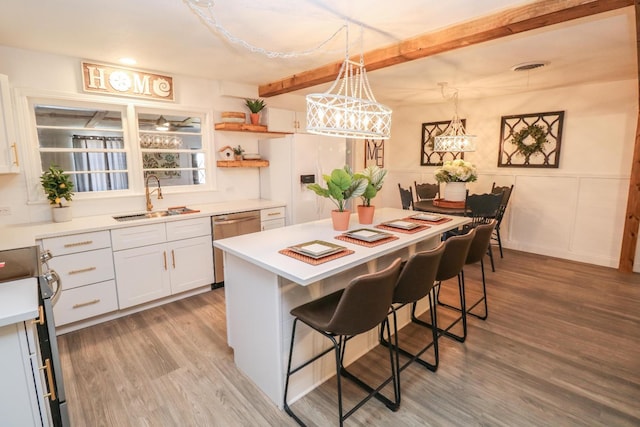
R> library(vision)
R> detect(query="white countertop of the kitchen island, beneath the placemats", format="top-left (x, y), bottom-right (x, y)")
top-left (213, 208), bottom-right (470, 285)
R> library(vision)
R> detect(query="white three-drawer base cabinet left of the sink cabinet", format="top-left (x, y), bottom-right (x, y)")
top-left (41, 231), bottom-right (118, 326)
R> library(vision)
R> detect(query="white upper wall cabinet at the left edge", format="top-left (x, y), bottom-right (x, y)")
top-left (0, 74), bottom-right (20, 173)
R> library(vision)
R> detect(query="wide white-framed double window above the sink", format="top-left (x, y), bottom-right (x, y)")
top-left (22, 94), bottom-right (213, 200)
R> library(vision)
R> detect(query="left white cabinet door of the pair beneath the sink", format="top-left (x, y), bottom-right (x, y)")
top-left (113, 245), bottom-right (171, 309)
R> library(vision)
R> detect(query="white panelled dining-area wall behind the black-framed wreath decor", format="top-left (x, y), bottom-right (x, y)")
top-left (376, 80), bottom-right (640, 271)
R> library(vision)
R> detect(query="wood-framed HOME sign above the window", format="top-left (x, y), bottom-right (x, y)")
top-left (82, 62), bottom-right (174, 101)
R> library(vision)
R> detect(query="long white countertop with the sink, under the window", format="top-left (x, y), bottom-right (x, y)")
top-left (0, 199), bottom-right (285, 250)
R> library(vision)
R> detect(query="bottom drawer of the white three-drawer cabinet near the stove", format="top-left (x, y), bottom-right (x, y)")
top-left (53, 280), bottom-right (118, 326)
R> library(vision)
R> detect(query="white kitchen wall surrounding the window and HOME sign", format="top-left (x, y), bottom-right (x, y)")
top-left (0, 46), bottom-right (296, 225)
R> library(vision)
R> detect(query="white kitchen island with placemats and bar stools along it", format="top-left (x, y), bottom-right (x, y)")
top-left (214, 208), bottom-right (469, 408)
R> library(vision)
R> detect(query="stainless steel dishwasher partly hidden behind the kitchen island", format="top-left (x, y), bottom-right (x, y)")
top-left (211, 211), bottom-right (260, 287)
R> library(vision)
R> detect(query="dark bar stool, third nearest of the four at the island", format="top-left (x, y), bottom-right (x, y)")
top-left (411, 228), bottom-right (476, 342)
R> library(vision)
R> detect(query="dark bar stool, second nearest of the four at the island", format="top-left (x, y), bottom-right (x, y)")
top-left (380, 242), bottom-right (445, 372)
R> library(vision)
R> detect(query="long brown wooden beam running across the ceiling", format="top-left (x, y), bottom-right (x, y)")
top-left (258, 0), bottom-right (634, 97)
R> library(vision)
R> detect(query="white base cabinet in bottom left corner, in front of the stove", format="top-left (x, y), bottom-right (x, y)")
top-left (0, 321), bottom-right (50, 427)
